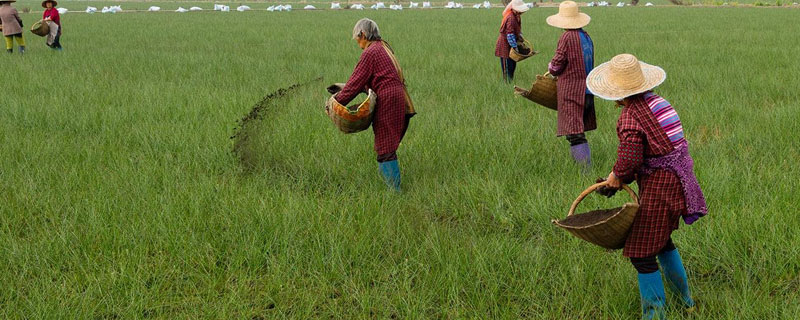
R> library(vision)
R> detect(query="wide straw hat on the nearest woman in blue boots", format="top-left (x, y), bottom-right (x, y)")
top-left (586, 53), bottom-right (667, 101)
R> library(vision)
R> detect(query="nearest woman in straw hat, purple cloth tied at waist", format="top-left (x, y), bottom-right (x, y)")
top-left (586, 54), bottom-right (708, 319)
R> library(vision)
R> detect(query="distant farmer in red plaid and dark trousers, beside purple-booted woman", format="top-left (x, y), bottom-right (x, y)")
top-left (494, 0), bottom-right (529, 83)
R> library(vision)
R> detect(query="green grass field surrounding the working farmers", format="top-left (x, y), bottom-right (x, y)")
top-left (0, 8), bottom-right (800, 319)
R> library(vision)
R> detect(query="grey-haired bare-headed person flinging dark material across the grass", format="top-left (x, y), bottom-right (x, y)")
top-left (334, 18), bottom-right (415, 191)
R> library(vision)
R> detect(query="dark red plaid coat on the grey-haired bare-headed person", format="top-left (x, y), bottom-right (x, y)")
top-left (336, 41), bottom-right (406, 155)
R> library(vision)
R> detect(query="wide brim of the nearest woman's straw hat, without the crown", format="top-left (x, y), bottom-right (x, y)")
top-left (586, 61), bottom-right (667, 101)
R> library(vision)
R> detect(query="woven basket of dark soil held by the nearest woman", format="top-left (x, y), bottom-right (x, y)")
top-left (553, 182), bottom-right (639, 249)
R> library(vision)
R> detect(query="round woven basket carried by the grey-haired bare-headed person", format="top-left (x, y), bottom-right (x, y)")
top-left (325, 90), bottom-right (377, 133)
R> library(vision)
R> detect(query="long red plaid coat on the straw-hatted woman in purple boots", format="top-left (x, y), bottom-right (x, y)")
top-left (549, 30), bottom-right (597, 136)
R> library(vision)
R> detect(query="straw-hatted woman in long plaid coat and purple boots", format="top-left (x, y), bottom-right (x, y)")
top-left (547, 1), bottom-right (597, 172)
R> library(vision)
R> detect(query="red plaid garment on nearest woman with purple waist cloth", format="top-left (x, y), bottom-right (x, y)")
top-left (614, 94), bottom-right (686, 258)
